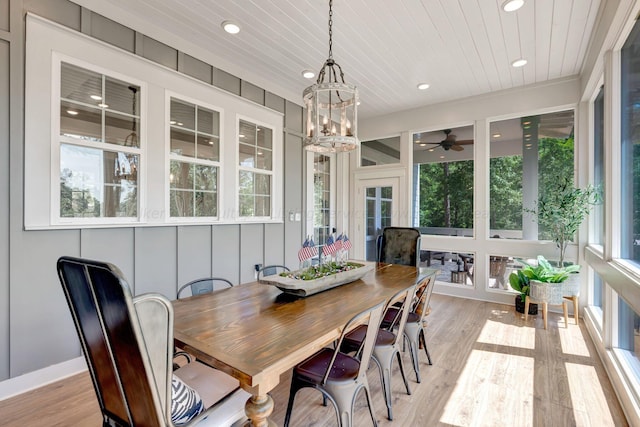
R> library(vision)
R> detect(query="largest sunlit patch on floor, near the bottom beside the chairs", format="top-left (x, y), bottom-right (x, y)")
top-left (440, 350), bottom-right (534, 427)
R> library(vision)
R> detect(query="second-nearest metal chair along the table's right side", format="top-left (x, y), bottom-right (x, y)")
top-left (342, 285), bottom-right (416, 420)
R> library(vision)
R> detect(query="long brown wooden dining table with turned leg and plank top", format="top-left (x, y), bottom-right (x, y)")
top-left (173, 263), bottom-right (437, 427)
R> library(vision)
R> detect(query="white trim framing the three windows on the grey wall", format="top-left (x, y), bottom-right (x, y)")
top-left (24, 14), bottom-right (284, 230)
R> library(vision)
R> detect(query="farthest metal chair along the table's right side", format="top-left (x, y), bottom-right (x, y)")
top-left (382, 275), bottom-right (436, 383)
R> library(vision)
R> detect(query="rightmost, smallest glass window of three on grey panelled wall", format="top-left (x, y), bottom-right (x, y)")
top-left (238, 120), bottom-right (273, 217)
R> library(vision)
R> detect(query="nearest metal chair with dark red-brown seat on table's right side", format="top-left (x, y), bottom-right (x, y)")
top-left (284, 303), bottom-right (384, 427)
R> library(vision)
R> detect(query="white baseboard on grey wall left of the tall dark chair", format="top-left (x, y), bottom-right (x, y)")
top-left (0, 357), bottom-right (87, 400)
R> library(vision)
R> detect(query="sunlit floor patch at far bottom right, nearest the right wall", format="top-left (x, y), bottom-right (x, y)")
top-left (565, 363), bottom-right (615, 426)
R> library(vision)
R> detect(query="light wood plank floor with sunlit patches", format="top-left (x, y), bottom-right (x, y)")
top-left (0, 295), bottom-right (627, 427)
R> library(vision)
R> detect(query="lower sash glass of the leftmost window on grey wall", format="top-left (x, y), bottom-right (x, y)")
top-left (60, 144), bottom-right (139, 218)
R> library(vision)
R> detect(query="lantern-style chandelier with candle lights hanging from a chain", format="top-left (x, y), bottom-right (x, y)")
top-left (302, 0), bottom-right (360, 153)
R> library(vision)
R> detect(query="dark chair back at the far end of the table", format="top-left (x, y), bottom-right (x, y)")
top-left (378, 227), bottom-right (420, 267)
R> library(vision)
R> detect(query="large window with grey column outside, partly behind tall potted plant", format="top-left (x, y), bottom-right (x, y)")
top-left (489, 110), bottom-right (574, 240)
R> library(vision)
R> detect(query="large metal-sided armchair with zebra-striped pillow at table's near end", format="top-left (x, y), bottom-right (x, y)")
top-left (57, 257), bottom-right (250, 427)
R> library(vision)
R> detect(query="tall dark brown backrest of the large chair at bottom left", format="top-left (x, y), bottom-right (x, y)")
top-left (57, 257), bottom-right (164, 426)
